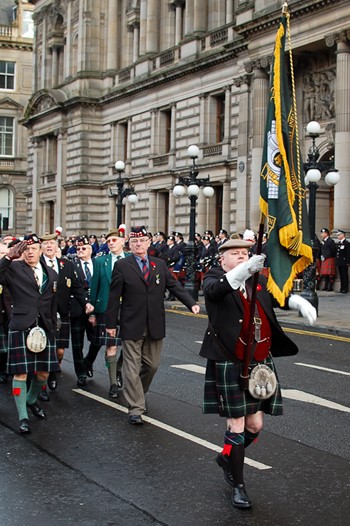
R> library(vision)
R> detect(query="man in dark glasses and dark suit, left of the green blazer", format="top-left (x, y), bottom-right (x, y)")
top-left (70, 236), bottom-right (99, 387)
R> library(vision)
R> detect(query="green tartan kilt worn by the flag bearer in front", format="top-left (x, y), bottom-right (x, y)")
top-left (203, 354), bottom-right (283, 418)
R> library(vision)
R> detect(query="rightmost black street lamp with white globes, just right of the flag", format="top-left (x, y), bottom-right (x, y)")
top-left (301, 121), bottom-right (340, 311)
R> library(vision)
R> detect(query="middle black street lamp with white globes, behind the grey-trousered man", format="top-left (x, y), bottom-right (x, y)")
top-left (173, 144), bottom-right (214, 300)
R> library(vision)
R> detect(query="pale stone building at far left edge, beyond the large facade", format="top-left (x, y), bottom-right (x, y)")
top-left (0, 0), bottom-right (34, 236)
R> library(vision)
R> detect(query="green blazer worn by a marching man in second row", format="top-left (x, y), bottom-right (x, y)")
top-left (90, 252), bottom-right (130, 314)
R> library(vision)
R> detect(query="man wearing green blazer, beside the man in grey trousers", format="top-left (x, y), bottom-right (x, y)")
top-left (84, 225), bottom-right (130, 398)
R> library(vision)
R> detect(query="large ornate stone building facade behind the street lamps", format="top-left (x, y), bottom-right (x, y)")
top-left (24, 0), bottom-right (350, 239)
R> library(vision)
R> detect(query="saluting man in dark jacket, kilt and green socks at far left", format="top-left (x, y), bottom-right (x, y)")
top-left (0, 234), bottom-right (59, 433)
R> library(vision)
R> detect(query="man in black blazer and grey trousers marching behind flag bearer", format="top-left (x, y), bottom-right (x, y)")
top-left (106, 226), bottom-right (199, 425)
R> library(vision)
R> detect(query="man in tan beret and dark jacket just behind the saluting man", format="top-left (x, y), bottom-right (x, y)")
top-left (40, 233), bottom-right (94, 400)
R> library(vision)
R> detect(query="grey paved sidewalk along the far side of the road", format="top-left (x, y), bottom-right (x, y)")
top-left (166, 291), bottom-right (350, 336)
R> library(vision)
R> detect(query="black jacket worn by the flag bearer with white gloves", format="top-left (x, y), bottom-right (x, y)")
top-left (199, 267), bottom-right (298, 361)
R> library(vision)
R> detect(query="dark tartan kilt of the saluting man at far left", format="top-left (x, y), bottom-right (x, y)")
top-left (8, 329), bottom-right (60, 374)
